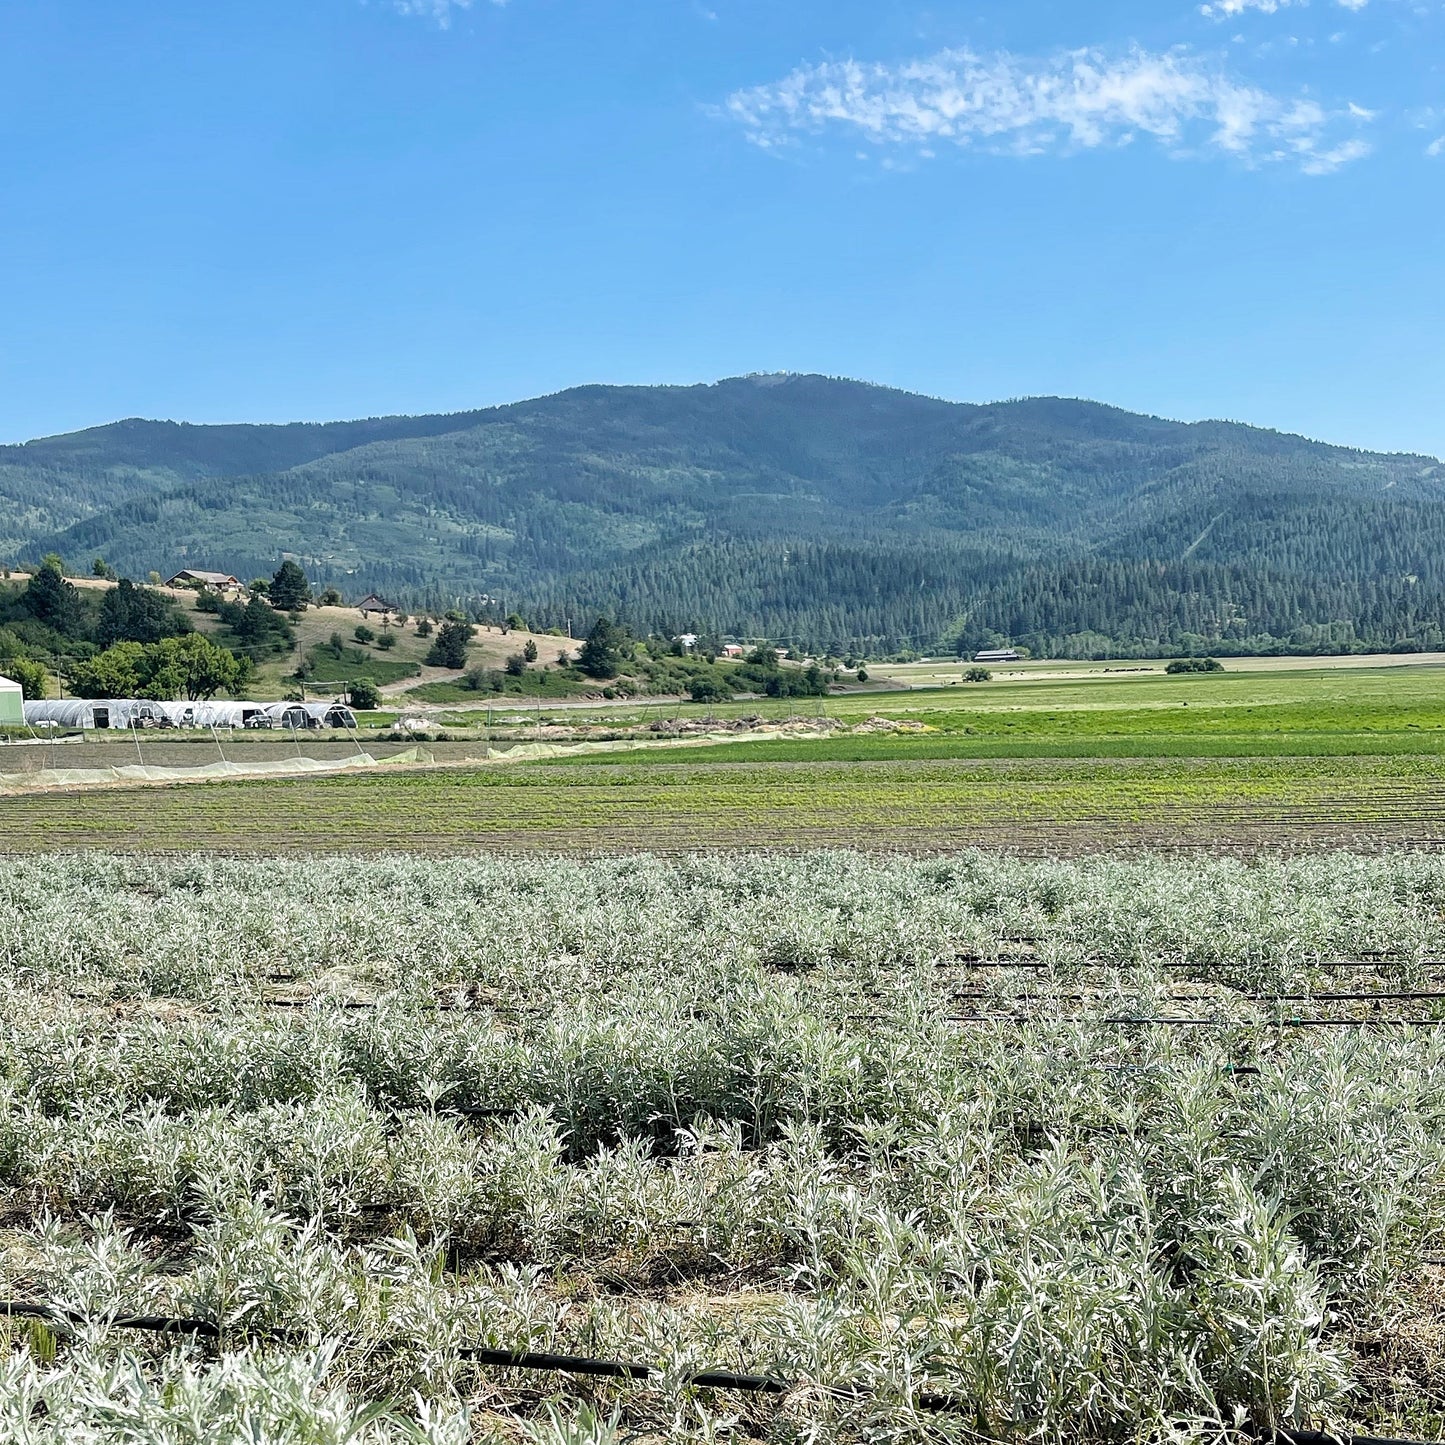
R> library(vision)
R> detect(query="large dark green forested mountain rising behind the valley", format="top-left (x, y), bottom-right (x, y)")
top-left (0, 376), bottom-right (1445, 656)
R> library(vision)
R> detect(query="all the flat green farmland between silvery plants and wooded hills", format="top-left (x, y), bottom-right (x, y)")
top-left (0, 665), bottom-right (1445, 853)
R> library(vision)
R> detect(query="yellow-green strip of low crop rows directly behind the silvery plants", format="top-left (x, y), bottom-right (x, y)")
top-left (8, 744), bottom-right (1445, 853)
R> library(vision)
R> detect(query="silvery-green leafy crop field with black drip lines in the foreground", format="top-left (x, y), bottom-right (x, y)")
top-left (0, 849), bottom-right (1445, 1445)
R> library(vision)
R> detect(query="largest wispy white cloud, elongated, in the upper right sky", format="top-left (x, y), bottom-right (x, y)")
top-left (725, 49), bottom-right (1370, 175)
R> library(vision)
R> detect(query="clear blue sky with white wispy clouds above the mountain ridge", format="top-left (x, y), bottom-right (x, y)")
top-left (0, 0), bottom-right (1445, 454)
